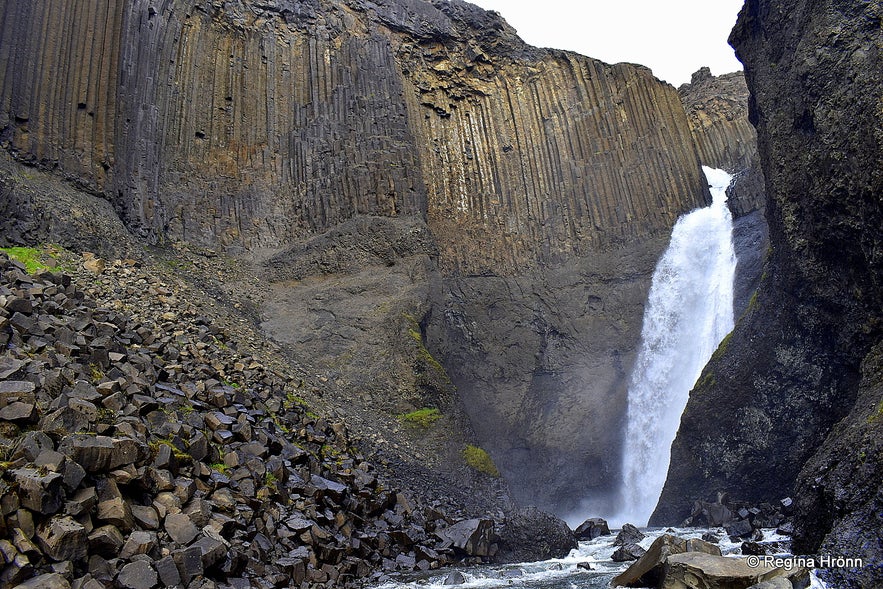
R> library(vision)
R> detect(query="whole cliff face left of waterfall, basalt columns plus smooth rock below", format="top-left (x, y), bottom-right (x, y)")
top-left (0, 0), bottom-right (720, 511)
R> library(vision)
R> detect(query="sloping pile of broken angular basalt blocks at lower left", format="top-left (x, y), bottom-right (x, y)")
top-left (0, 254), bottom-right (512, 589)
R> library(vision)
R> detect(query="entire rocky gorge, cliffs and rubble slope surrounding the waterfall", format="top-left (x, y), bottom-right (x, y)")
top-left (0, 0), bottom-right (883, 587)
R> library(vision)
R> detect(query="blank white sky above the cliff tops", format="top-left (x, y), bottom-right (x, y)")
top-left (468, 0), bottom-right (743, 87)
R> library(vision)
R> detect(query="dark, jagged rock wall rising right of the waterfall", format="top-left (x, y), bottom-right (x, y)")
top-left (651, 0), bottom-right (883, 587)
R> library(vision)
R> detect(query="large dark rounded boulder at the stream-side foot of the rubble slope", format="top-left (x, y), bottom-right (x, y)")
top-left (494, 507), bottom-right (578, 563)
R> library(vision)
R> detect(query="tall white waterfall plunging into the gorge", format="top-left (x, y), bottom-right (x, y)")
top-left (613, 166), bottom-right (736, 525)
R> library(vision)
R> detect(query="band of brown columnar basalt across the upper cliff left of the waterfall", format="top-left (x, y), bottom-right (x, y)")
top-left (0, 0), bottom-right (703, 262)
